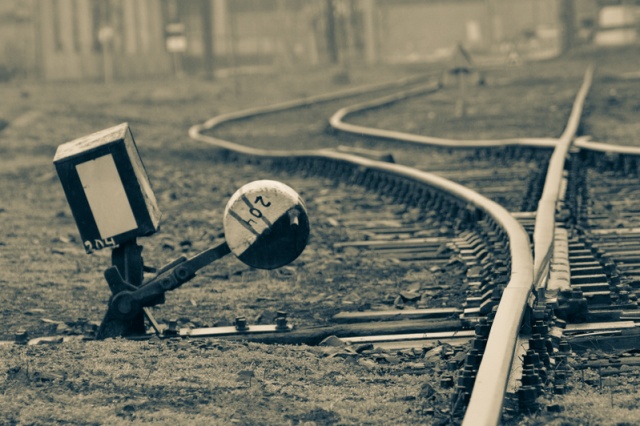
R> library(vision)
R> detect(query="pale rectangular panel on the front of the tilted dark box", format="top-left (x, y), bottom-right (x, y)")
top-left (76, 154), bottom-right (138, 239)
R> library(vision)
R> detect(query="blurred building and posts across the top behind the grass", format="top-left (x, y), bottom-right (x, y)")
top-left (0, 0), bottom-right (640, 81)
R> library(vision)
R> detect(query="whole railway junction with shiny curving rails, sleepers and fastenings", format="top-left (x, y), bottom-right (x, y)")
top-left (6, 59), bottom-right (640, 424)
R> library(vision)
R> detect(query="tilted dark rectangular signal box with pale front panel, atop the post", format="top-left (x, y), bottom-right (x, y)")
top-left (53, 123), bottom-right (160, 253)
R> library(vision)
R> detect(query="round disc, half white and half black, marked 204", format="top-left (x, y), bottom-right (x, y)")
top-left (223, 180), bottom-right (309, 269)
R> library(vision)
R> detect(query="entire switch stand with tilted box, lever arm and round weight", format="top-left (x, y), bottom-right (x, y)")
top-left (54, 123), bottom-right (310, 339)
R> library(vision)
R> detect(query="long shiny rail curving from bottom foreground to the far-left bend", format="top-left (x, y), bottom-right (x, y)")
top-left (189, 75), bottom-right (533, 424)
